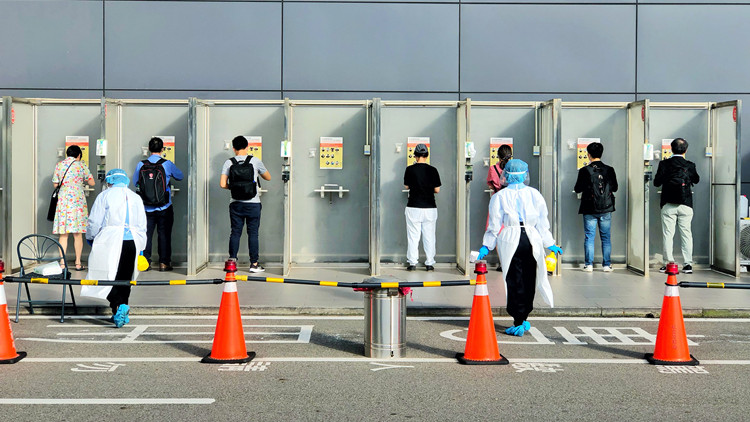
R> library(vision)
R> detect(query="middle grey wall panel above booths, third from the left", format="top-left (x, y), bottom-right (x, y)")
top-left (284, 3), bottom-right (458, 91)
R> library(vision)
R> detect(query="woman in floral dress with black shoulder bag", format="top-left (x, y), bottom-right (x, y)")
top-left (52, 145), bottom-right (94, 271)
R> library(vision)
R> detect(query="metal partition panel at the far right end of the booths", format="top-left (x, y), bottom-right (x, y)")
top-left (711, 101), bottom-right (742, 277)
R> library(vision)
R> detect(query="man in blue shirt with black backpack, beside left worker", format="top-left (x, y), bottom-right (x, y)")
top-left (133, 137), bottom-right (183, 271)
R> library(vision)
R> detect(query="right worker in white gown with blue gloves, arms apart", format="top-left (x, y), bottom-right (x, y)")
top-left (478, 159), bottom-right (562, 337)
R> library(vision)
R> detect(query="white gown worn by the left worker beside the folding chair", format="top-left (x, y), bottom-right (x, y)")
top-left (81, 186), bottom-right (146, 299)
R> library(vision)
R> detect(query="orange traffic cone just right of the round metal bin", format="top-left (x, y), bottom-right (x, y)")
top-left (456, 261), bottom-right (508, 365)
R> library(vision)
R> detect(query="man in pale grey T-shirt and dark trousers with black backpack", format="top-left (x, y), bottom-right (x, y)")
top-left (219, 136), bottom-right (271, 273)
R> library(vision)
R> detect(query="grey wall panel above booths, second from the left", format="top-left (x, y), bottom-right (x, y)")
top-left (105, 2), bottom-right (281, 90)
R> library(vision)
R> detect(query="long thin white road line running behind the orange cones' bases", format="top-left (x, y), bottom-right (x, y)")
top-left (19, 356), bottom-right (750, 365)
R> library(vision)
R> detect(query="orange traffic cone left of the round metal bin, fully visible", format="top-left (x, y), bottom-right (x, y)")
top-left (201, 261), bottom-right (255, 363)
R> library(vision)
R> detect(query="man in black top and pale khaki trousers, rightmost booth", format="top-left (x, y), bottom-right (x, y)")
top-left (654, 138), bottom-right (700, 274)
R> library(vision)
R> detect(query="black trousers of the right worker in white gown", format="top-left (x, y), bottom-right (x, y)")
top-left (505, 227), bottom-right (537, 325)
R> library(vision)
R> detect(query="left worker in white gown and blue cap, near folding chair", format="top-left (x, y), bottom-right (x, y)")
top-left (81, 169), bottom-right (146, 328)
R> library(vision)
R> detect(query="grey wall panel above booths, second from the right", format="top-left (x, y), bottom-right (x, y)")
top-left (461, 5), bottom-right (636, 92)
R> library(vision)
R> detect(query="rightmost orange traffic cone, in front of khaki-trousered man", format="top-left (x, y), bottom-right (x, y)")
top-left (645, 262), bottom-right (698, 365)
